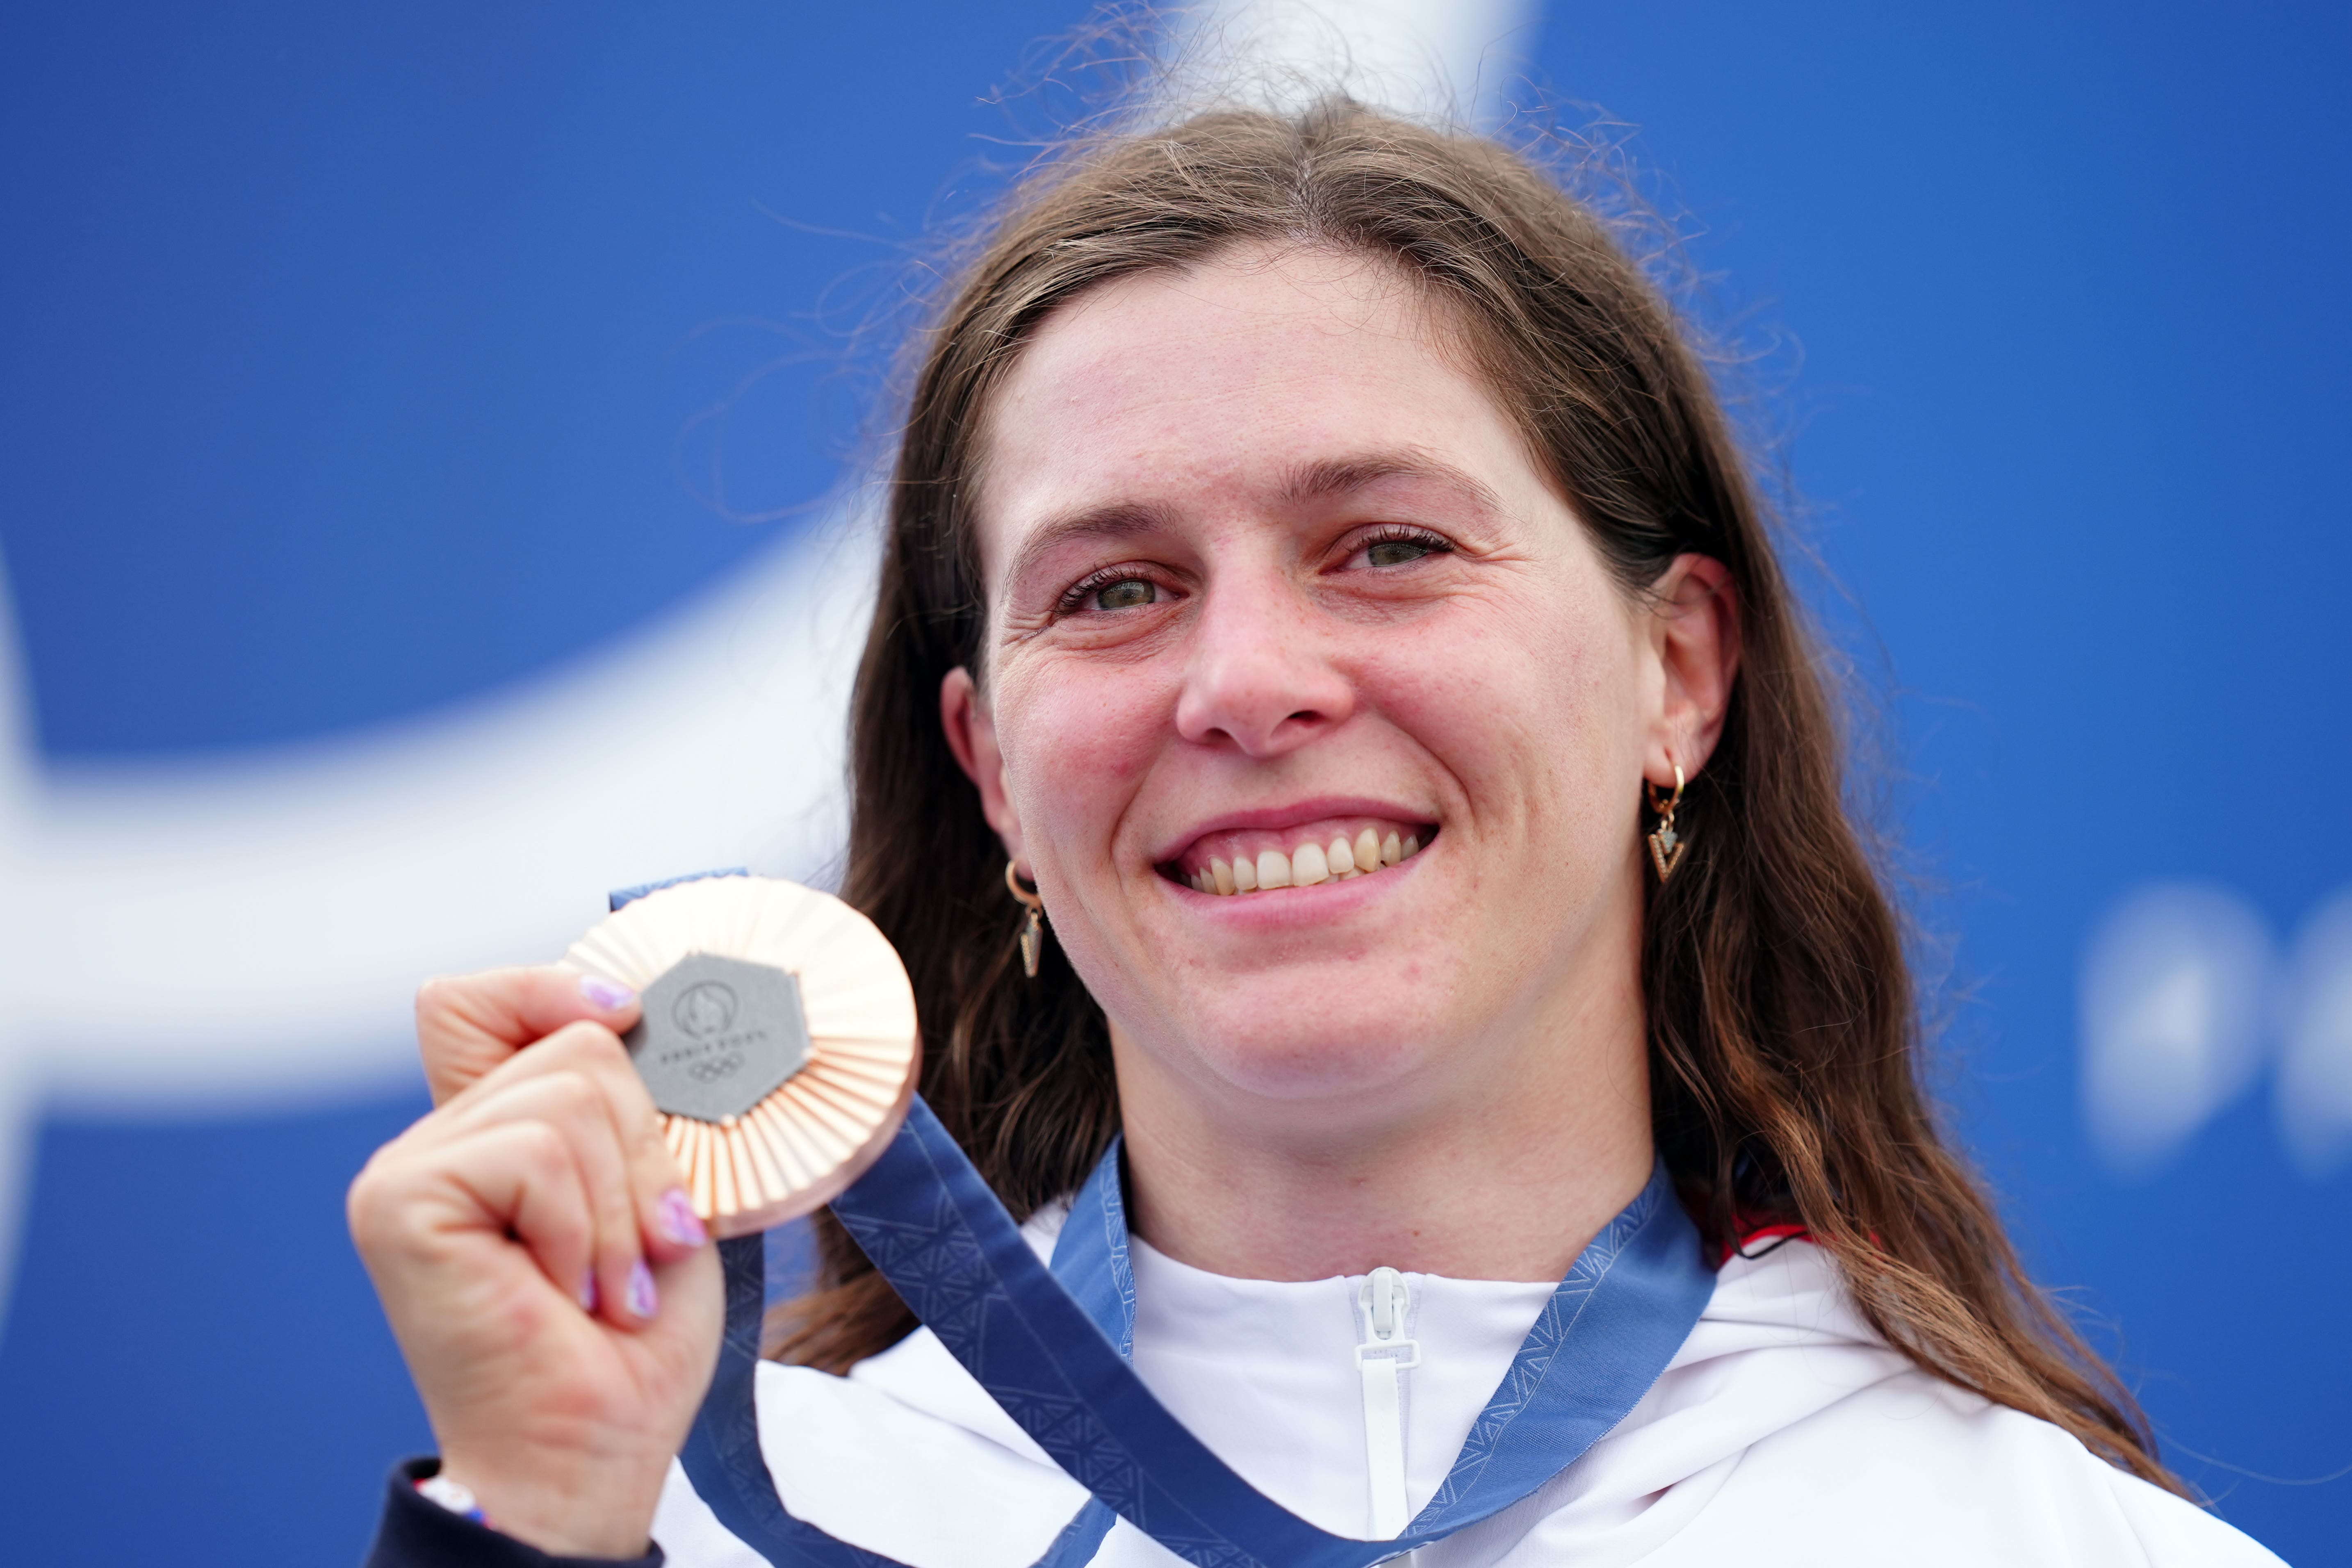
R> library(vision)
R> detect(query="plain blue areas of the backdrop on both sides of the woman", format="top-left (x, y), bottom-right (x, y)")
top-left (0, 0), bottom-right (2352, 1563)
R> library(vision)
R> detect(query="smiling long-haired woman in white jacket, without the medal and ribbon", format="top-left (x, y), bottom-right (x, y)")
top-left (351, 103), bottom-right (2272, 1568)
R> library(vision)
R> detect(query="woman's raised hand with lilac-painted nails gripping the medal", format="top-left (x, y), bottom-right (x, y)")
top-left (351, 969), bottom-right (722, 1556)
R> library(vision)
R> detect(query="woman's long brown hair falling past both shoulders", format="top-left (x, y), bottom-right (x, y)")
top-left (781, 99), bottom-right (2178, 1488)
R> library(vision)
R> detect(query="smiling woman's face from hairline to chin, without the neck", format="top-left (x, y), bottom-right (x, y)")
top-left (943, 249), bottom-right (1715, 1147)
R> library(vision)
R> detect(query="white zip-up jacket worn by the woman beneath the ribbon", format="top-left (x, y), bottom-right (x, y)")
top-left (654, 1206), bottom-right (2279, 1568)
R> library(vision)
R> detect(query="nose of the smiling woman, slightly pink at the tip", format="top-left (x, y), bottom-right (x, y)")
top-left (1176, 581), bottom-right (1355, 757)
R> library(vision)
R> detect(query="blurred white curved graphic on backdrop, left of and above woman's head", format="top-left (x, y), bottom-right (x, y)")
top-left (0, 0), bottom-right (1534, 1312)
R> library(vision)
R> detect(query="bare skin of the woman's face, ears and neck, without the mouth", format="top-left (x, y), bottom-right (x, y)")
top-left (943, 239), bottom-right (1736, 1279)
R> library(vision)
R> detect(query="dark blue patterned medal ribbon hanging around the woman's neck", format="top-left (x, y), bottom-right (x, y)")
top-left (680, 1098), bottom-right (1715, 1568)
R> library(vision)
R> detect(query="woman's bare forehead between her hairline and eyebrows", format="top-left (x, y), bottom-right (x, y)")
top-left (981, 249), bottom-right (1527, 581)
